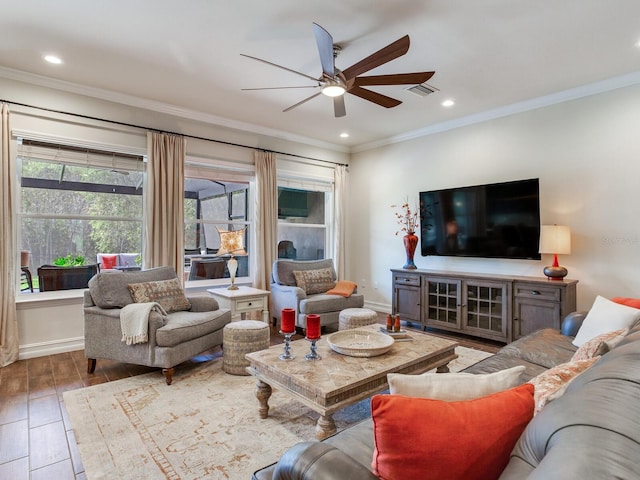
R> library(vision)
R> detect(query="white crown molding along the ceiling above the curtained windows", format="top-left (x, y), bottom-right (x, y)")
top-left (0, 66), bottom-right (350, 153)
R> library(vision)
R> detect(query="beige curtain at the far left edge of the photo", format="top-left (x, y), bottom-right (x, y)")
top-left (0, 103), bottom-right (19, 367)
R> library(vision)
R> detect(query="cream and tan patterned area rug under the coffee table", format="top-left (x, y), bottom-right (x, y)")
top-left (64, 347), bottom-right (490, 480)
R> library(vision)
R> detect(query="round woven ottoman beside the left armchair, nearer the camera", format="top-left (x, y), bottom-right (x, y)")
top-left (222, 320), bottom-right (269, 375)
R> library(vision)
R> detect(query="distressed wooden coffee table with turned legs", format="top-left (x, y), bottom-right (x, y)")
top-left (246, 324), bottom-right (458, 440)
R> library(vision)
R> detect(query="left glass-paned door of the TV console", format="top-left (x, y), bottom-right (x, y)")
top-left (422, 277), bottom-right (462, 330)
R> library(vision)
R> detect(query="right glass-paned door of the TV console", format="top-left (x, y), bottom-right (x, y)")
top-left (462, 280), bottom-right (511, 342)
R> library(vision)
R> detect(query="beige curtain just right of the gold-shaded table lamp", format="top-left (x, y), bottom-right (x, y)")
top-left (253, 152), bottom-right (278, 290)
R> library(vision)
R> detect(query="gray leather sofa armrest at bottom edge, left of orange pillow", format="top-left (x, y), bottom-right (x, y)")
top-left (273, 442), bottom-right (378, 480)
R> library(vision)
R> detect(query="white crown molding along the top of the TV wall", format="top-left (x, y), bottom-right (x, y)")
top-left (351, 71), bottom-right (640, 153)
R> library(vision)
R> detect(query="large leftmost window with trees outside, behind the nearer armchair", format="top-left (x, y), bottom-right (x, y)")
top-left (18, 140), bottom-right (144, 293)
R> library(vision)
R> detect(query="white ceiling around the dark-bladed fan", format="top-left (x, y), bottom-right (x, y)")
top-left (0, 0), bottom-right (640, 148)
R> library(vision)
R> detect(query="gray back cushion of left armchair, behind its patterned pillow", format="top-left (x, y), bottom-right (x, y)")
top-left (89, 267), bottom-right (177, 308)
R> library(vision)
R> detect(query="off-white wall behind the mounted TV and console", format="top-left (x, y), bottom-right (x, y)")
top-left (347, 86), bottom-right (640, 309)
